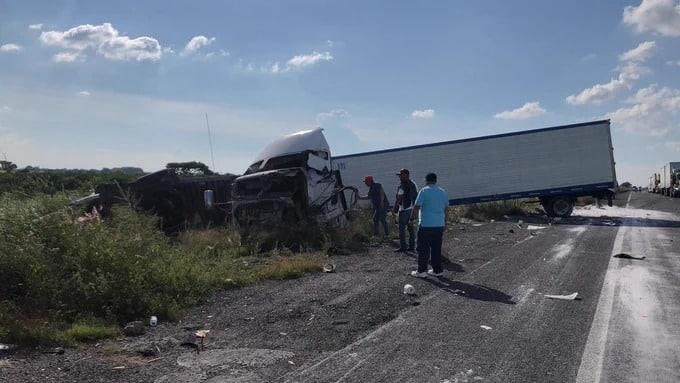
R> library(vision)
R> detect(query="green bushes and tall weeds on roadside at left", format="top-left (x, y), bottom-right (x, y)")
top-left (0, 194), bottom-right (320, 344)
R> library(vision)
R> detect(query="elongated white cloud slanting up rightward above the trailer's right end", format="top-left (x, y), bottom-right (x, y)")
top-left (566, 62), bottom-right (649, 105)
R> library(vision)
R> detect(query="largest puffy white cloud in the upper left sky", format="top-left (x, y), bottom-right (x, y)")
top-left (40, 23), bottom-right (162, 62)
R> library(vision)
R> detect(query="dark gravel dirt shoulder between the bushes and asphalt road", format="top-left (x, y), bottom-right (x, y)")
top-left (0, 216), bottom-right (547, 383)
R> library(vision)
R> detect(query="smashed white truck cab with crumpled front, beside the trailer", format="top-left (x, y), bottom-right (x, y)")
top-left (232, 129), bottom-right (356, 231)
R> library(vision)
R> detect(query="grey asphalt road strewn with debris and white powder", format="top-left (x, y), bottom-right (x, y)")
top-left (285, 193), bottom-right (680, 382)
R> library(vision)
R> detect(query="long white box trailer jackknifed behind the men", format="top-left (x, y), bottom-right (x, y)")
top-left (332, 120), bottom-right (617, 217)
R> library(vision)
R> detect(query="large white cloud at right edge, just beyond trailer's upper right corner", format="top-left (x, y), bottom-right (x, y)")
top-left (607, 85), bottom-right (680, 136)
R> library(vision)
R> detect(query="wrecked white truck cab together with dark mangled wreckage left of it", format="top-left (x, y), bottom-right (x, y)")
top-left (71, 129), bottom-right (358, 234)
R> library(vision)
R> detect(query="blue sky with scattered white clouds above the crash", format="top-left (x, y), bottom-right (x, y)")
top-left (0, 0), bottom-right (680, 184)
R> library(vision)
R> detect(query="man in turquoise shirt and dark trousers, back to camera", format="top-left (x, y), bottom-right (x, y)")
top-left (411, 173), bottom-right (449, 278)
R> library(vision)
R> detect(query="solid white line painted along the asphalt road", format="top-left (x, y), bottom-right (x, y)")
top-left (576, 193), bottom-right (633, 383)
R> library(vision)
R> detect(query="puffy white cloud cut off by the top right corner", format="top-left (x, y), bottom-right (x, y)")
top-left (623, 0), bottom-right (680, 37)
